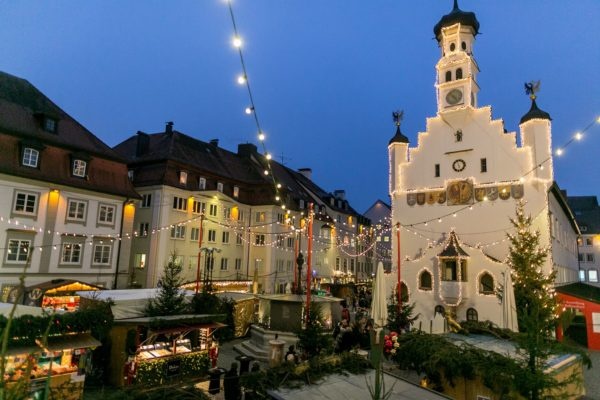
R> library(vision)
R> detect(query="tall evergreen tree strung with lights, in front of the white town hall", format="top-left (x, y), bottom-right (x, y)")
top-left (507, 202), bottom-right (558, 400)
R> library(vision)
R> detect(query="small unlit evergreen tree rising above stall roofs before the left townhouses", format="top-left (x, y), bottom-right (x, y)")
top-left (146, 256), bottom-right (188, 317)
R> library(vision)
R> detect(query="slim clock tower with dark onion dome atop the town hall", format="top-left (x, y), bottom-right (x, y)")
top-left (433, 0), bottom-right (479, 112)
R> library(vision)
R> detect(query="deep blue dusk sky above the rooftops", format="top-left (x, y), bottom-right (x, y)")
top-left (0, 0), bottom-right (600, 212)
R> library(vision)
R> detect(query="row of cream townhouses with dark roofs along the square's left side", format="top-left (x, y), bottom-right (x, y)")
top-left (0, 69), bottom-right (375, 300)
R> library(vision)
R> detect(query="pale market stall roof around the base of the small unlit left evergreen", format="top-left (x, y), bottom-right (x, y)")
top-left (77, 288), bottom-right (194, 320)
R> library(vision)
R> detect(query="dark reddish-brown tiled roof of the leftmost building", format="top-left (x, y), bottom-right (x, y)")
top-left (0, 72), bottom-right (138, 198)
